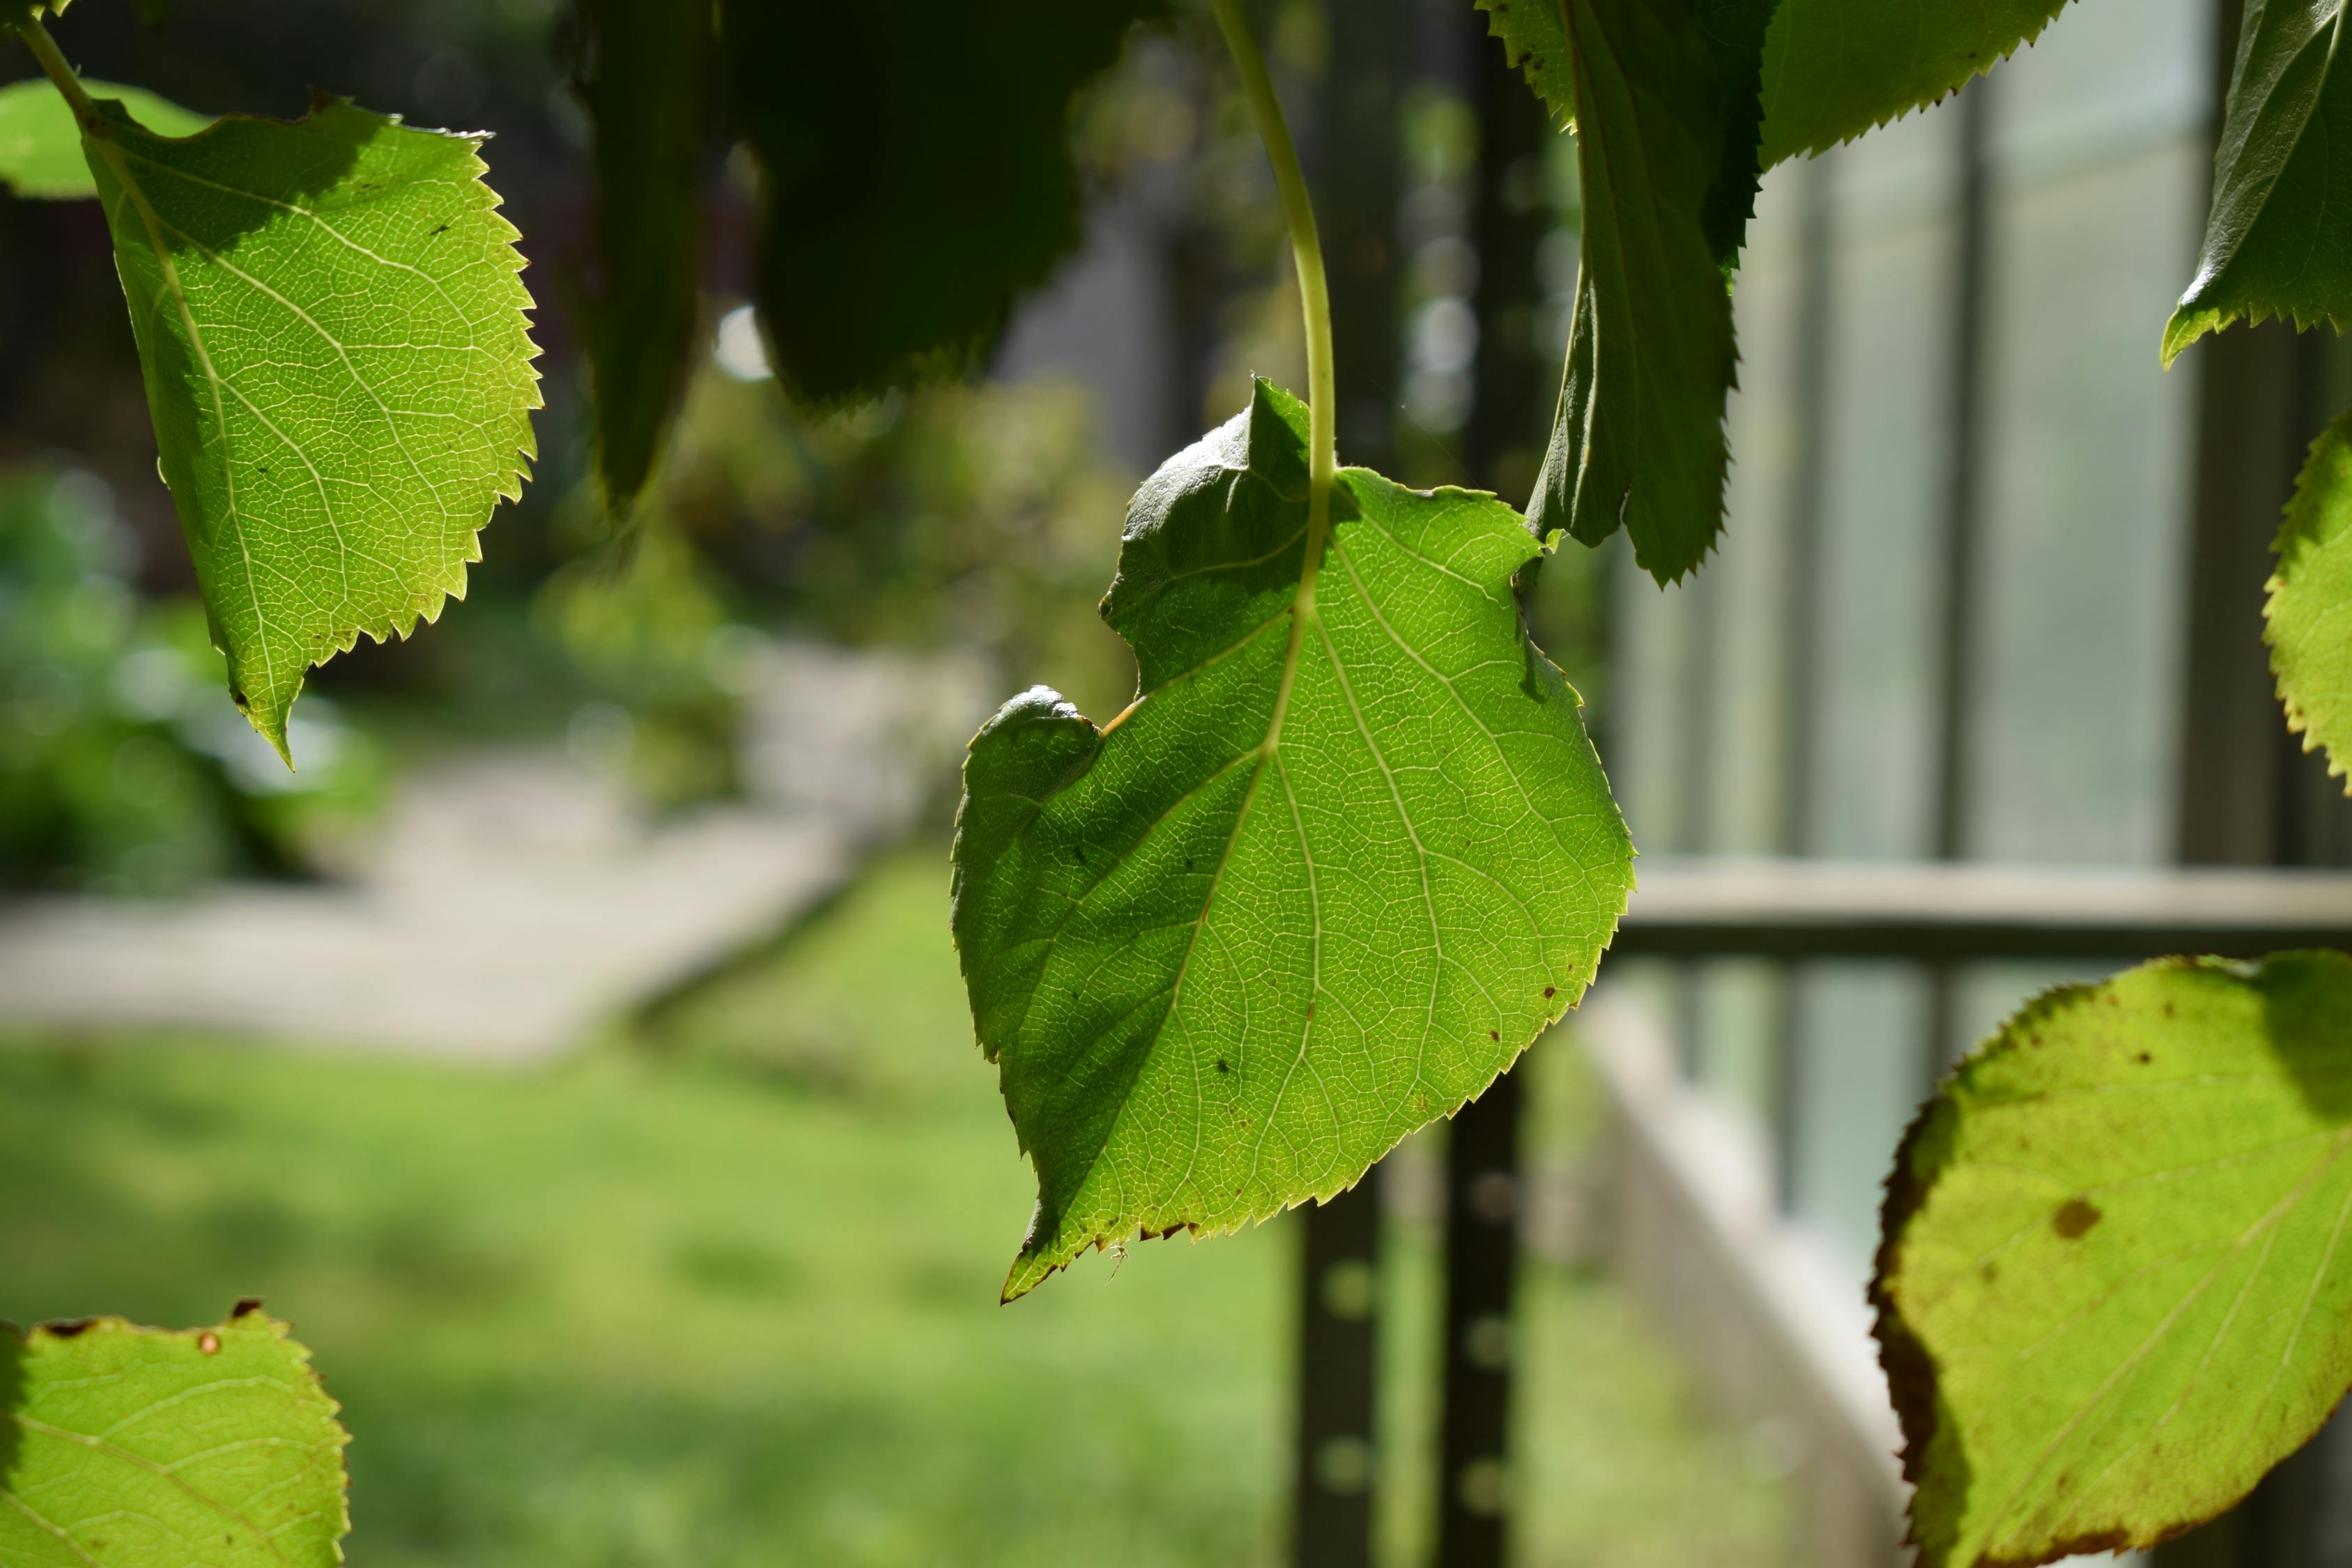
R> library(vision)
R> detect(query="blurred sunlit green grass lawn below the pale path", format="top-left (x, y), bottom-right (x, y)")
top-left (0, 851), bottom-right (1783, 1568)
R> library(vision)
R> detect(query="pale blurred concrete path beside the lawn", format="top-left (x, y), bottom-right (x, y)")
top-left (0, 649), bottom-right (988, 1060)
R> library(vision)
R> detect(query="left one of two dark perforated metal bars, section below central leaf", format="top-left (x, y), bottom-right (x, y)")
top-left (1291, 1189), bottom-right (1381, 1568)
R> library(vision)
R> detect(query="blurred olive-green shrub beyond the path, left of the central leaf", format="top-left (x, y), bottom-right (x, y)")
top-left (611, 355), bottom-right (1136, 712)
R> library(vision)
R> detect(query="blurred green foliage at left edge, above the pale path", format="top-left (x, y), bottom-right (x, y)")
top-left (0, 468), bottom-right (376, 893)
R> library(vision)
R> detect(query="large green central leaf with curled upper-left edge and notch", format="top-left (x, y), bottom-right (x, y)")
top-left (955, 381), bottom-right (1632, 1300)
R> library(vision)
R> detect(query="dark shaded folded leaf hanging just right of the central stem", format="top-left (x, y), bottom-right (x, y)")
top-left (1529, 0), bottom-right (1774, 583)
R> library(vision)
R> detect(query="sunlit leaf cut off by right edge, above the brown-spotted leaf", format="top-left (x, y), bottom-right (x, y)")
top-left (2263, 414), bottom-right (2352, 776)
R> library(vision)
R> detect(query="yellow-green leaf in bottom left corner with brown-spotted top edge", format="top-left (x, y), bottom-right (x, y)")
top-left (0, 1309), bottom-right (351, 1568)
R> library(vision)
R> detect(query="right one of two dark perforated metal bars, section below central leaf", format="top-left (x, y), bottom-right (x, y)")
top-left (1437, 1072), bottom-right (1519, 1568)
